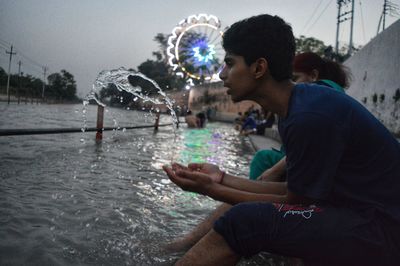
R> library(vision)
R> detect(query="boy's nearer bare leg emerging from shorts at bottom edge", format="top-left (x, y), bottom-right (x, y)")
top-left (176, 230), bottom-right (240, 266)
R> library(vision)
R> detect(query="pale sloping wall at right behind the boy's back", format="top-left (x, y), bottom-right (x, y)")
top-left (344, 20), bottom-right (400, 135)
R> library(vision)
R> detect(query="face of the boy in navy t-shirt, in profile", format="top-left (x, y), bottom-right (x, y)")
top-left (219, 53), bottom-right (255, 102)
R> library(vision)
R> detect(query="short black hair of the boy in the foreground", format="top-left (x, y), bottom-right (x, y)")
top-left (222, 14), bottom-right (296, 81)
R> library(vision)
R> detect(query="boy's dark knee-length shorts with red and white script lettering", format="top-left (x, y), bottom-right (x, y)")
top-left (214, 202), bottom-right (400, 265)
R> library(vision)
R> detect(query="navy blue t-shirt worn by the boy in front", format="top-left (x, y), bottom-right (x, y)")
top-left (279, 84), bottom-right (400, 222)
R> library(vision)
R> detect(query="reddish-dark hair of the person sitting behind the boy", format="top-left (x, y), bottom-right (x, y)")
top-left (293, 52), bottom-right (351, 88)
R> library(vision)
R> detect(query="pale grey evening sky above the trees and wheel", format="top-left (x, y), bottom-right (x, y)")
top-left (0, 0), bottom-right (400, 97)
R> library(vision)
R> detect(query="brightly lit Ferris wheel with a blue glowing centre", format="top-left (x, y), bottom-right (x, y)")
top-left (167, 14), bottom-right (224, 81)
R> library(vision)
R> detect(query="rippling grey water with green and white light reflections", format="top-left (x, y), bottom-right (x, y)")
top-left (0, 103), bottom-right (290, 265)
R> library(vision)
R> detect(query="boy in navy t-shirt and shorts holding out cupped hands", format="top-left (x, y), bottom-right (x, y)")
top-left (164, 15), bottom-right (400, 265)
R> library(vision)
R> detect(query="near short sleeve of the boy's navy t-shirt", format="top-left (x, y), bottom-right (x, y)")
top-left (285, 113), bottom-right (345, 200)
